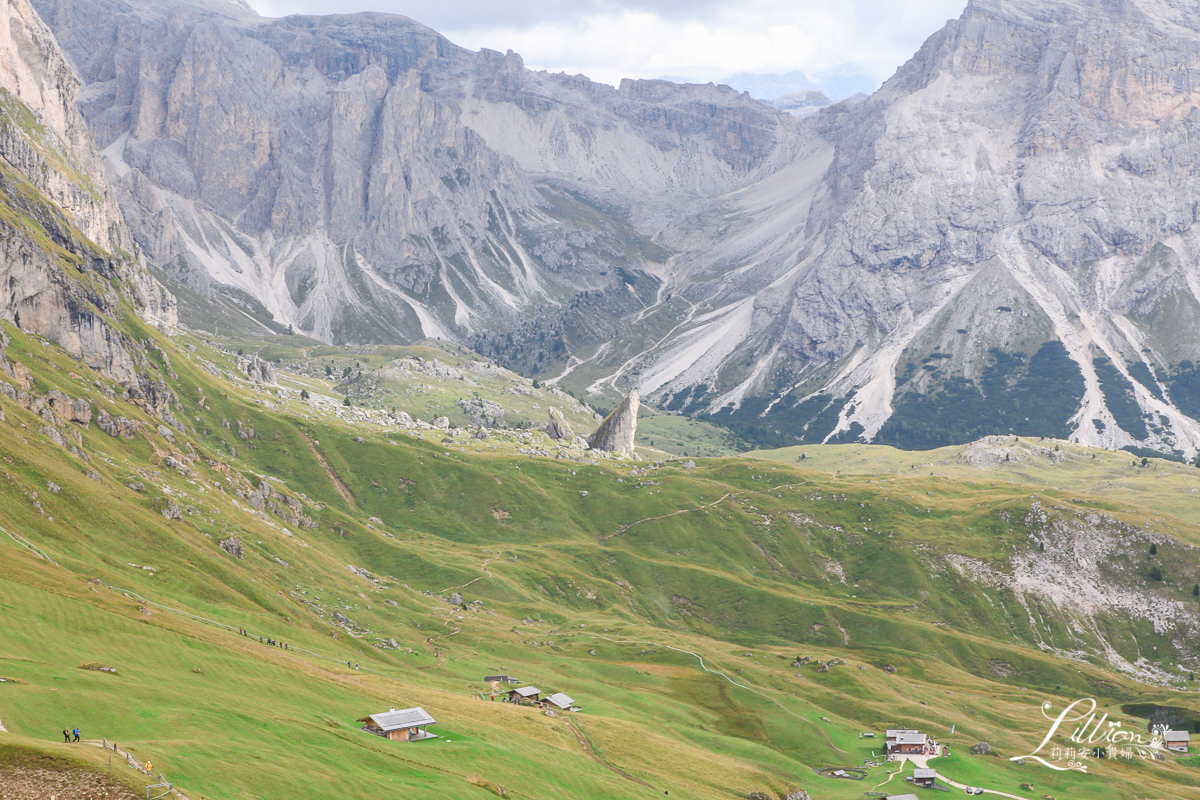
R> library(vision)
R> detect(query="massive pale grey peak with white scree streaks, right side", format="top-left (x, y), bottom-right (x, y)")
top-left (626, 0), bottom-right (1200, 457)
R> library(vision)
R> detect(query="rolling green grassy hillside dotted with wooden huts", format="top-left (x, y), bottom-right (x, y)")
top-left (0, 317), bottom-right (1200, 800)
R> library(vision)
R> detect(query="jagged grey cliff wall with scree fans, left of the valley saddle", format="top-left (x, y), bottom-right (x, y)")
top-left (30, 0), bottom-right (785, 350)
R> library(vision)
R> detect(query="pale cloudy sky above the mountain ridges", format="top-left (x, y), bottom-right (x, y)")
top-left (248, 0), bottom-right (966, 91)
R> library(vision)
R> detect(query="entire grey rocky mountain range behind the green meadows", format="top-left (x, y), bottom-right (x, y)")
top-left (23, 0), bottom-right (1200, 459)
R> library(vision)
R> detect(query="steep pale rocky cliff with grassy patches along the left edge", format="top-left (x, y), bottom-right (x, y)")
top-left (0, 0), bottom-right (175, 386)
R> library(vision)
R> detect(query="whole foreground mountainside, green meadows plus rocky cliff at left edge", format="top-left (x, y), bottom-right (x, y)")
top-left (7, 0), bottom-right (1200, 800)
